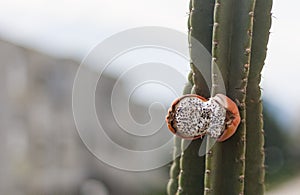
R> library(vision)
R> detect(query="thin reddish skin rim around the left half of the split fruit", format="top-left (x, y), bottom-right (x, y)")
top-left (166, 94), bottom-right (207, 140)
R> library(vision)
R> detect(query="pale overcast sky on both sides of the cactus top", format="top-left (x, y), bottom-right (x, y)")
top-left (0, 0), bottom-right (300, 127)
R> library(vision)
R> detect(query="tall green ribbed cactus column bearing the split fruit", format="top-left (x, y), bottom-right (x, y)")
top-left (168, 0), bottom-right (272, 195)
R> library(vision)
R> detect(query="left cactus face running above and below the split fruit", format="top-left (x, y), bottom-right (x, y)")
top-left (177, 0), bottom-right (214, 195)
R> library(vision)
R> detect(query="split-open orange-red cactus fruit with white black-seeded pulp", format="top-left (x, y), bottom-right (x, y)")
top-left (166, 94), bottom-right (240, 141)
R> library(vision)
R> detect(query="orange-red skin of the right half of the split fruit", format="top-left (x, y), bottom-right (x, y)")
top-left (214, 94), bottom-right (241, 142)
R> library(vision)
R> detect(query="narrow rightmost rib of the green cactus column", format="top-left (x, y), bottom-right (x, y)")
top-left (245, 0), bottom-right (272, 195)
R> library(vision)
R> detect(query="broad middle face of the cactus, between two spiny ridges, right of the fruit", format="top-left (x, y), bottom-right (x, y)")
top-left (205, 0), bottom-right (255, 194)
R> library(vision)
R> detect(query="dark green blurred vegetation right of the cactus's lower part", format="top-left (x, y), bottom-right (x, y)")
top-left (263, 103), bottom-right (300, 190)
